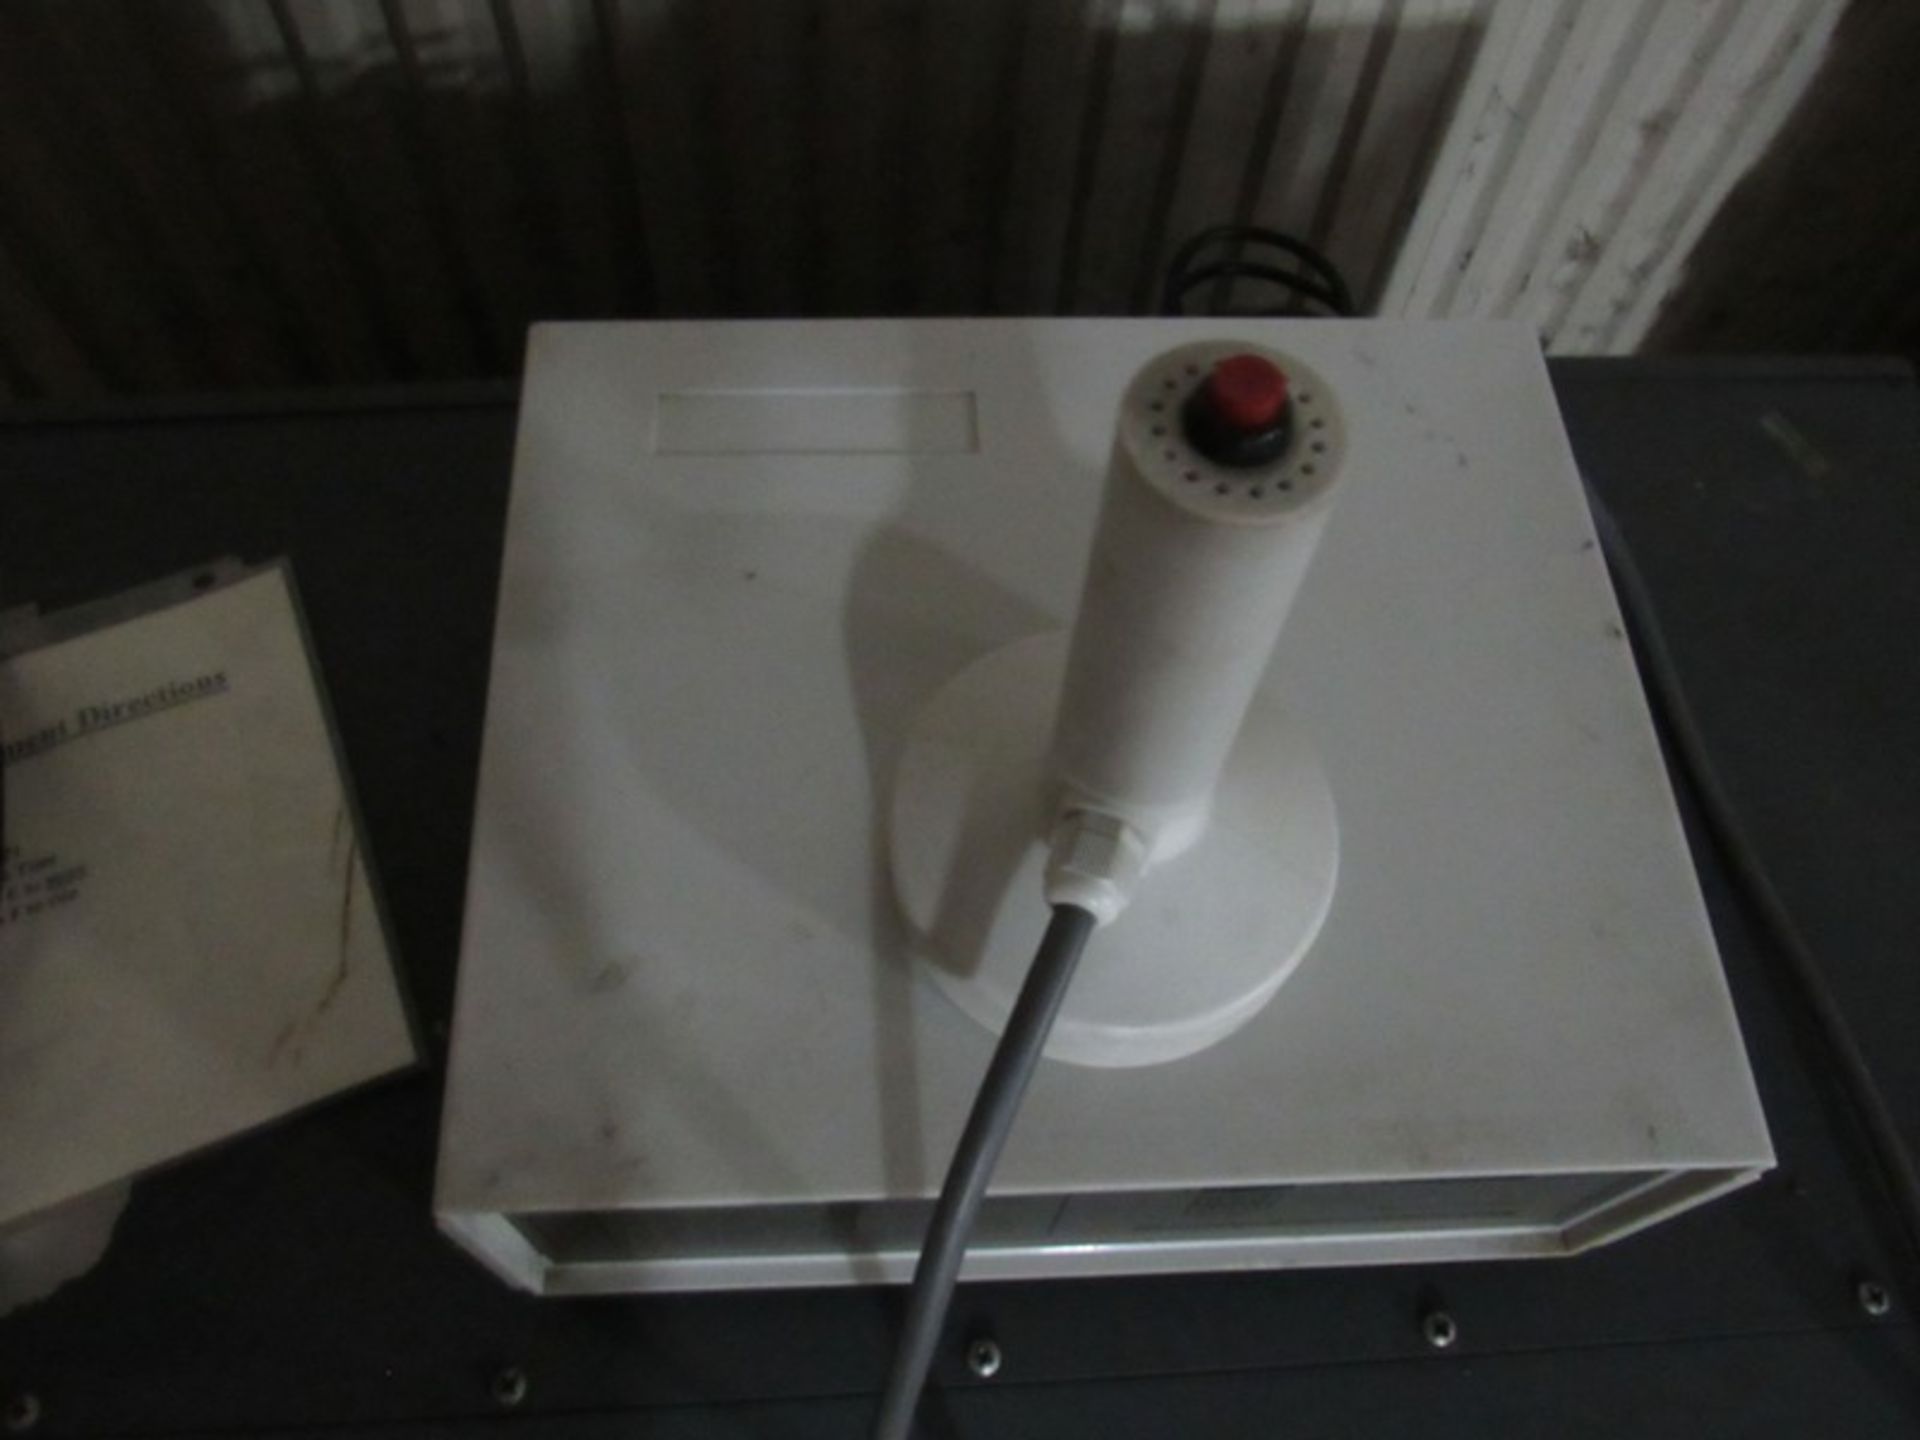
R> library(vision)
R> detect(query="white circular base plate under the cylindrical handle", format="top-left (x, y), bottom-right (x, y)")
top-left (887, 634), bottom-right (1340, 1066)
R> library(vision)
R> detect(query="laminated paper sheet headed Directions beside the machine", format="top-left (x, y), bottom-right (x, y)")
top-left (0, 568), bottom-right (415, 1227)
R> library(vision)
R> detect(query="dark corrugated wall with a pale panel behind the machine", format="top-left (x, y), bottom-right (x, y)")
top-left (0, 0), bottom-right (1920, 403)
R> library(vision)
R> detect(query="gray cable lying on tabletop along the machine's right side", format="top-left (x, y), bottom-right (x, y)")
top-left (1586, 484), bottom-right (1920, 1282)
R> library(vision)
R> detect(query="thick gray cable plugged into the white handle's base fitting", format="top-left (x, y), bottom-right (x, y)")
top-left (874, 904), bottom-right (1096, 1440)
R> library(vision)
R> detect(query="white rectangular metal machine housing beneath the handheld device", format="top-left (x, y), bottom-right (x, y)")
top-left (436, 321), bottom-right (1772, 1294)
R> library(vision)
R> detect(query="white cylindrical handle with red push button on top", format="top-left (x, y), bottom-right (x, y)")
top-left (1054, 342), bottom-right (1344, 858)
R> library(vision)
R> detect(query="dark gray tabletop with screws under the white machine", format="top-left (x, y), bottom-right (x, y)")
top-left (0, 361), bottom-right (1920, 1440)
